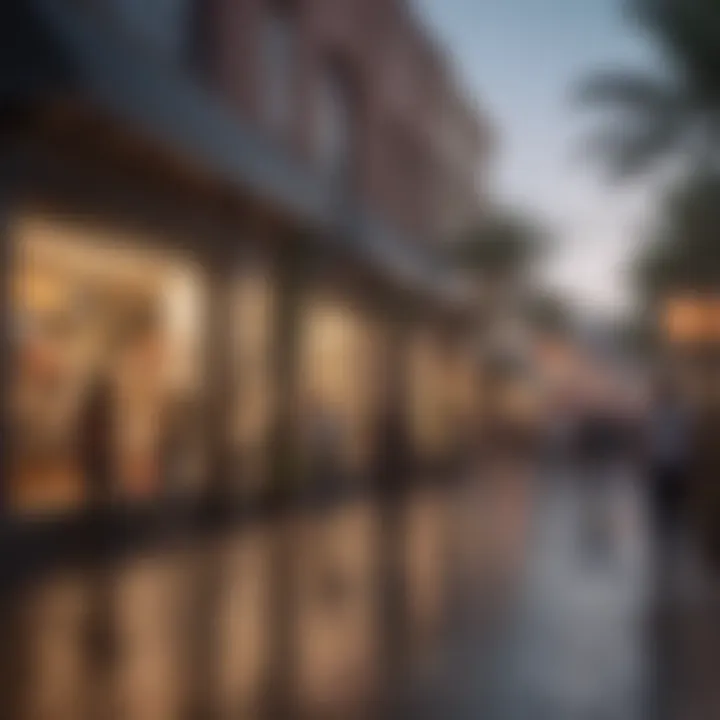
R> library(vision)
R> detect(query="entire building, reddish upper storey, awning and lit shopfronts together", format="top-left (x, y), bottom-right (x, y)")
top-left (0, 0), bottom-right (489, 556)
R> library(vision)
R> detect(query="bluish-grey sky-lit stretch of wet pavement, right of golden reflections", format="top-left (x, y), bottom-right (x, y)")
top-left (396, 466), bottom-right (649, 720)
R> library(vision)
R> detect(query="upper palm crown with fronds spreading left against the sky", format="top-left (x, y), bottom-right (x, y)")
top-left (578, 0), bottom-right (720, 176)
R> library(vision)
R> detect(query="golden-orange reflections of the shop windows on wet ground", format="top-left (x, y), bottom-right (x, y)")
top-left (2, 470), bottom-right (522, 720)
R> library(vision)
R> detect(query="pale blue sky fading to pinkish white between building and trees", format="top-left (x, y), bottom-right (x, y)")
top-left (415, 0), bottom-right (664, 311)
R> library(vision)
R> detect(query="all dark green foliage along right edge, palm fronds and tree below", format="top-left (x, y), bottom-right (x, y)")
top-left (577, 0), bottom-right (720, 310)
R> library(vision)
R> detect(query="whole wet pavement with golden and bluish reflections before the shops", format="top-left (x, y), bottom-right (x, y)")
top-left (5, 468), bottom-right (720, 720)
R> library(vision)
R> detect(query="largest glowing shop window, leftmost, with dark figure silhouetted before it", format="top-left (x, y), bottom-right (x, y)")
top-left (9, 218), bottom-right (204, 512)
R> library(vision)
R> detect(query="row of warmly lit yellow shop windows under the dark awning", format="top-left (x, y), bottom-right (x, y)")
top-left (8, 212), bottom-right (476, 514)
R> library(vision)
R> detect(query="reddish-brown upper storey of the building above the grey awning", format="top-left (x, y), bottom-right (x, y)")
top-left (205, 0), bottom-right (489, 241)
